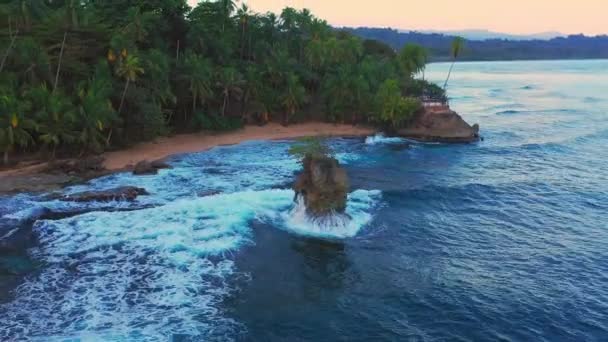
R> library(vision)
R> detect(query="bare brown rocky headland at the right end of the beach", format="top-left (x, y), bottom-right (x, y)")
top-left (397, 107), bottom-right (479, 143)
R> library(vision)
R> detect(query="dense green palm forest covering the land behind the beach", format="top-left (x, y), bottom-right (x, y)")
top-left (0, 0), bottom-right (445, 163)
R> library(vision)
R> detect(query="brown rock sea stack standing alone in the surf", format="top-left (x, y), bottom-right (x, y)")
top-left (293, 156), bottom-right (349, 216)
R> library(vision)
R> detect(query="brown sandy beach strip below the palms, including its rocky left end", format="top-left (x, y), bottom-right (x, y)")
top-left (0, 122), bottom-right (376, 194)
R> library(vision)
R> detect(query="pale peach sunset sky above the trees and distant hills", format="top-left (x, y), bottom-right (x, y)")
top-left (190, 0), bottom-right (608, 35)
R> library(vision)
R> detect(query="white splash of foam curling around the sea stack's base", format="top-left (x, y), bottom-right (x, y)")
top-left (283, 190), bottom-right (381, 239)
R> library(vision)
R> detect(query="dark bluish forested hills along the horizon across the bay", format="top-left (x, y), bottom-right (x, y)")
top-left (344, 27), bottom-right (608, 61)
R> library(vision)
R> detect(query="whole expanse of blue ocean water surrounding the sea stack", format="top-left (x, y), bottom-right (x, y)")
top-left (0, 61), bottom-right (608, 341)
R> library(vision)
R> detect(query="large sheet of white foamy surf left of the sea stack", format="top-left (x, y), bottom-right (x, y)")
top-left (0, 190), bottom-right (293, 341)
